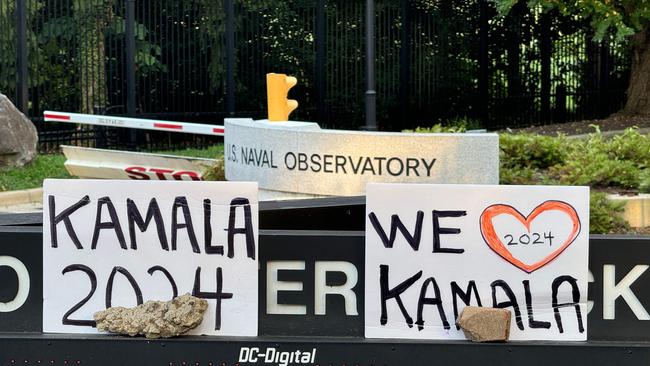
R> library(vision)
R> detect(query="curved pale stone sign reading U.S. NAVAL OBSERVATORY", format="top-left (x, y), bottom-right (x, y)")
top-left (224, 118), bottom-right (499, 196)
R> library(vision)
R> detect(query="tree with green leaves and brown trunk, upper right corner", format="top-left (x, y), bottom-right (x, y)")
top-left (492, 0), bottom-right (650, 115)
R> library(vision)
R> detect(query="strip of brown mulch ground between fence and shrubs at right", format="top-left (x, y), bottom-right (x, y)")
top-left (510, 115), bottom-right (650, 136)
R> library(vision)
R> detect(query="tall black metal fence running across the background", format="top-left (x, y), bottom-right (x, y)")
top-left (0, 0), bottom-right (630, 150)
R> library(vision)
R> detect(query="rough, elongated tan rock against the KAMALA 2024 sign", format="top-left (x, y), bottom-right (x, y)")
top-left (94, 294), bottom-right (208, 338)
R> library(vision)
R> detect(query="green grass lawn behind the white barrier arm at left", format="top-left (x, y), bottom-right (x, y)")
top-left (0, 144), bottom-right (223, 191)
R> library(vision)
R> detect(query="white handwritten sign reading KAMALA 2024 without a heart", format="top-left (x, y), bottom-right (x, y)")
top-left (43, 180), bottom-right (258, 336)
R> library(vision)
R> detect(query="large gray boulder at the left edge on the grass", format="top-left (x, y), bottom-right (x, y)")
top-left (0, 93), bottom-right (38, 167)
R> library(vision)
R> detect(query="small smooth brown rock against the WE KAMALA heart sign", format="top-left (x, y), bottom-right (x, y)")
top-left (457, 306), bottom-right (510, 342)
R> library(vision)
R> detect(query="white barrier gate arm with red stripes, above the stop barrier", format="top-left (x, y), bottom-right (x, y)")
top-left (43, 111), bottom-right (224, 136)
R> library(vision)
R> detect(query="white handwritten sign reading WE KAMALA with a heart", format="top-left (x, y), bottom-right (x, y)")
top-left (365, 184), bottom-right (589, 340)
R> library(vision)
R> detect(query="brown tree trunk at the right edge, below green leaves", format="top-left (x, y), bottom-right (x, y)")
top-left (620, 27), bottom-right (650, 115)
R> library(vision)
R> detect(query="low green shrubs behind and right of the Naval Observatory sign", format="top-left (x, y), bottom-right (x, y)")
top-left (412, 124), bottom-right (650, 233)
